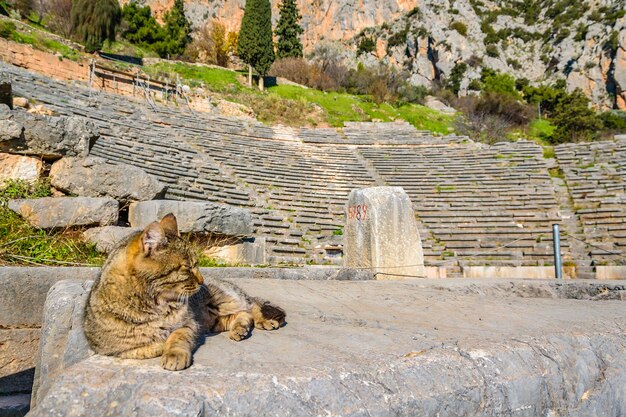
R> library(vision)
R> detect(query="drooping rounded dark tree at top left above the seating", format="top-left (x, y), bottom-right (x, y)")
top-left (71, 0), bottom-right (121, 52)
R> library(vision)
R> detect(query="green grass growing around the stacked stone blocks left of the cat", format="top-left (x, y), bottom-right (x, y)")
top-left (0, 181), bottom-right (104, 266)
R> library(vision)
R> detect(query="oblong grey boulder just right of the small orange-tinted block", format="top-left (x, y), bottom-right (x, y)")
top-left (50, 156), bottom-right (165, 203)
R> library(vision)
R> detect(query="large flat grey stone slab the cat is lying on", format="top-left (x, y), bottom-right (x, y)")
top-left (31, 280), bottom-right (626, 416)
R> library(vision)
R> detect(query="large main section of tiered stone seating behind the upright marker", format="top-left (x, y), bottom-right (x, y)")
top-left (0, 63), bottom-right (569, 267)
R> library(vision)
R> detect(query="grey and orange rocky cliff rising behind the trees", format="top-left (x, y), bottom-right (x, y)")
top-left (132, 0), bottom-right (626, 109)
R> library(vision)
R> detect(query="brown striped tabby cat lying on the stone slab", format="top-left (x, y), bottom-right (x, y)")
top-left (84, 214), bottom-right (285, 371)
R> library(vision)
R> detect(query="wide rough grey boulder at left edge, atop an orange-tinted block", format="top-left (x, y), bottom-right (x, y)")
top-left (0, 105), bottom-right (98, 160)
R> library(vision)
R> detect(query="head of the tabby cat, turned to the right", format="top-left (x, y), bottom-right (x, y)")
top-left (125, 214), bottom-right (204, 301)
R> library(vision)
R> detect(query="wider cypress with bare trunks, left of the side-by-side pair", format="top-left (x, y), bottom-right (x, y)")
top-left (238, 0), bottom-right (275, 90)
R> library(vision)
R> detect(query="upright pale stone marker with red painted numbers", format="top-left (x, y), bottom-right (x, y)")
top-left (344, 187), bottom-right (425, 279)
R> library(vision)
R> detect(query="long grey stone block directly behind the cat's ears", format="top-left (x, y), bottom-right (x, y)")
top-left (128, 200), bottom-right (254, 236)
